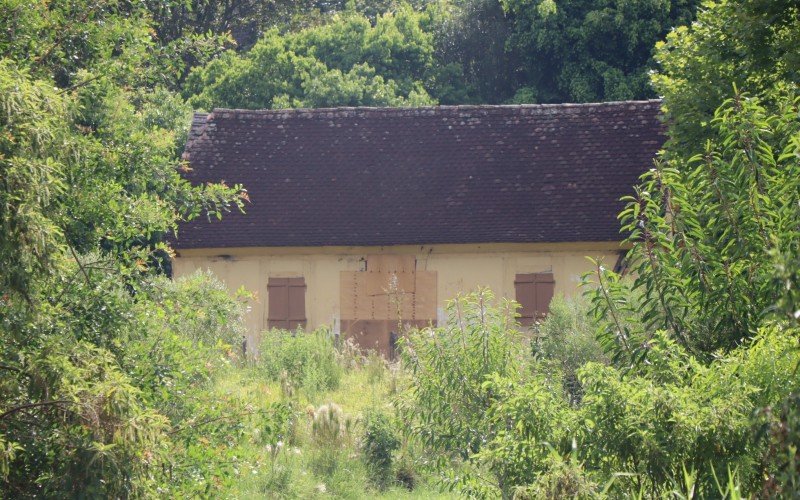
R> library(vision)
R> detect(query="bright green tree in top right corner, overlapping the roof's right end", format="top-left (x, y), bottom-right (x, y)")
top-left (653, 0), bottom-right (800, 153)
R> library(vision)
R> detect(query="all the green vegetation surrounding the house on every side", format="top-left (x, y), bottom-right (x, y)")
top-left (0, 0), bottom-right (800, 498)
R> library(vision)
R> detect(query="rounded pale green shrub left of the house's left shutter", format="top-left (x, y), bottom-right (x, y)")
top-left (121, 271), bottom-right (244, 422)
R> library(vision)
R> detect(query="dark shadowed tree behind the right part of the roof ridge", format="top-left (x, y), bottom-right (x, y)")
top-left (501, 0), bottom-right (699, 102)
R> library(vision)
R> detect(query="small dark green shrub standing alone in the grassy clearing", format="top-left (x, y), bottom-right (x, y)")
top-left (361, 410), bottom-right (400, 490)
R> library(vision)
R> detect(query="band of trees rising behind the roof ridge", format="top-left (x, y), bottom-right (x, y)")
top-left (178, 0), bottom-right (698, 109)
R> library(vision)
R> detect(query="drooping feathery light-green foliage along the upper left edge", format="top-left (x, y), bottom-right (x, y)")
top-left (0, 59), bottom-right (68, 297)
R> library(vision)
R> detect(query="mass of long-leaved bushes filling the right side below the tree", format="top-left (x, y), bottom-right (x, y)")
top-left (403, 11), bottom-right (800, 488)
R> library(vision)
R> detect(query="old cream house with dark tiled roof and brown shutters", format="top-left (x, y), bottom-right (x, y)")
top-left (174, 101), bottom-right (664, 352)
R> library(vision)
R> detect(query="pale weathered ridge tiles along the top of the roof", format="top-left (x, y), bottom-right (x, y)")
top-left (206, 99), bottom-right (662, 118)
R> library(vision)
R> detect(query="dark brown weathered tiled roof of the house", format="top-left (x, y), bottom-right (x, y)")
top-left (175, 101), bottom-right (664, 249)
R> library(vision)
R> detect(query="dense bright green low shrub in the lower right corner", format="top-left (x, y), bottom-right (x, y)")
top-left (578, 327), bottom-right (800, 496)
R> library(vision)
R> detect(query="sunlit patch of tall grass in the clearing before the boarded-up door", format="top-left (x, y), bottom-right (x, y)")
top-left (203, 329), bottom-right (452, 499)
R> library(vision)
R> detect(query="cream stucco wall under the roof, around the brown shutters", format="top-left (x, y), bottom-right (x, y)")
top-left (173, 242), bottom-right (622, 352)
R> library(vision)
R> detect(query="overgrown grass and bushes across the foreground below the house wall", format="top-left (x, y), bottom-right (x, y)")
top-left (142, 284), bottom-right (800, 499)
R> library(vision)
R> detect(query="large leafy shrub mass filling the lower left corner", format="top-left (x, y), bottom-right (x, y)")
top-left (0, 266), bottom-right (248, 497)
